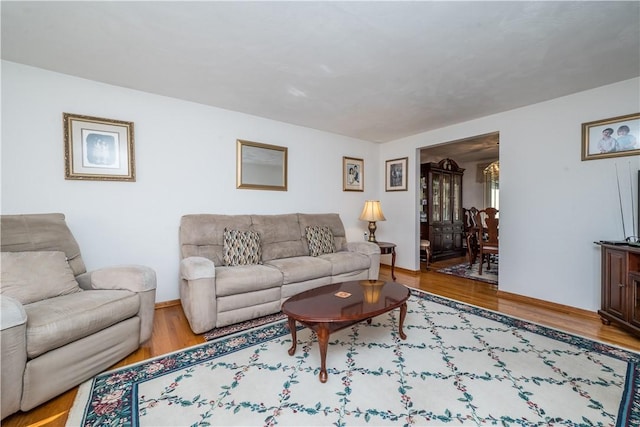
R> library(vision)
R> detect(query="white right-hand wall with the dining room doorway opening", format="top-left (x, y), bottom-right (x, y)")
top-left (381, 78), bottom-right (640, 310)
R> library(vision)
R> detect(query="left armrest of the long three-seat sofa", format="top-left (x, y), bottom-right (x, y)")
top-left (180, 257), bottom-right (218, 334)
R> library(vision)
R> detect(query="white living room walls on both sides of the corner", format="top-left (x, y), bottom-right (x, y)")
top-left (1, 61), bottom-right (640, 310)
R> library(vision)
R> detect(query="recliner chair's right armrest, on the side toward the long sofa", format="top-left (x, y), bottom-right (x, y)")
top-left (76, 265), bottom-right (156, 344)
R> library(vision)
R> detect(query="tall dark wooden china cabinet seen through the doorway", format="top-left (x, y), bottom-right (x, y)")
top-left (420, 159), bottom-right (464, 260)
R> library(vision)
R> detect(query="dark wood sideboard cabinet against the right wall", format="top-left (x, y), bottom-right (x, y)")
top-left (598, 243), bottom-right (640, 336)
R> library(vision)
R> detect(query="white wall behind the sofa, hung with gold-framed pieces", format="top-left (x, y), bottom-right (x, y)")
top-left (1, 61), bottom-right (379, 301)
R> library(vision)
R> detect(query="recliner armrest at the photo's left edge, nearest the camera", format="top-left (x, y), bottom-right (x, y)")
top-left (0, 295), bottom-right (27, 419)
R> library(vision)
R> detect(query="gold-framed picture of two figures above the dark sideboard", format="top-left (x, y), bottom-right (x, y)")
top-left (582, 113), bottom-right (640, 160)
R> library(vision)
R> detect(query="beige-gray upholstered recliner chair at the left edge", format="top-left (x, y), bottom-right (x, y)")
top-left (0, 213), bottom-right (156, 418)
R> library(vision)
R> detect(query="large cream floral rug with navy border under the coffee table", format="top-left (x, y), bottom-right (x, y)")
top-left (67, 290), bottom-right (640, 426)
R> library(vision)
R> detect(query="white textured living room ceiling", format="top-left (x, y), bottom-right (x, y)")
top-left (1, 1), bottom-right (640, 142)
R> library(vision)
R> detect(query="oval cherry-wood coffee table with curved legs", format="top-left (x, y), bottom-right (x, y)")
top-left (282, 280), bottom-right (409, 383)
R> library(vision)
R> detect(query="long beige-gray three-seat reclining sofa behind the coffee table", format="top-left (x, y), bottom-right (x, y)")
top-left (179, 213), bottom-right (380, 334)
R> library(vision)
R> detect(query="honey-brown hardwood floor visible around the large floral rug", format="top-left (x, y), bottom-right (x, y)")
top-left (2, 258), bottom-right (640, 427)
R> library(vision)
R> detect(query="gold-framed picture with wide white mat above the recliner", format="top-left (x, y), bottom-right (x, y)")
top-left (63, 113), bottom-right (136, 181)
